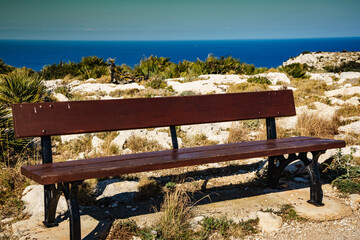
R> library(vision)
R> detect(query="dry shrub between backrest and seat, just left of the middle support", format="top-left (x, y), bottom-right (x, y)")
top-left (125, 136), bottom-right (164, 153)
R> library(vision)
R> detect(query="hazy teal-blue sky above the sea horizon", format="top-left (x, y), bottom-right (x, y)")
top-left (0, 0), bottom-right (360, 40)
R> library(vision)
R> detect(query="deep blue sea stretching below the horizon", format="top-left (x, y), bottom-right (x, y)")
top-left (0, 38), bottom-right (360, 71)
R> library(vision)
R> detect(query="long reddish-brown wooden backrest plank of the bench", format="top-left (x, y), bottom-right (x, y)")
top-left (12, 90), bottom-right (296, 138)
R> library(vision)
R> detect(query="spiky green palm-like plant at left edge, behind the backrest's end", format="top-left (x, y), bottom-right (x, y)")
top-left (0, 70), bottom-right (45, 106)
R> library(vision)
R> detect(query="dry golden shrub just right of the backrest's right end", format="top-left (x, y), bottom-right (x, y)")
top-left (296, 113), bottom-right (339, 138)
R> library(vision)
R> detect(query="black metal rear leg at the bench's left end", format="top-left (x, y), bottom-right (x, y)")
top-left (43, 184), bottom-right (61, 227)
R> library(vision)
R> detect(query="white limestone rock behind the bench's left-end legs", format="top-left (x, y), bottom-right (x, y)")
top-left (21, 185), bottom-right (67, 217)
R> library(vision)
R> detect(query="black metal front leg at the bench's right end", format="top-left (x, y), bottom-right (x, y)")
top-left (306, 151), bottom-right (324, 207)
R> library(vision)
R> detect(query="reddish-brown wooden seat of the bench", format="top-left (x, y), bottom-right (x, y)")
top-left (21, 137), bottom-right (345, 184)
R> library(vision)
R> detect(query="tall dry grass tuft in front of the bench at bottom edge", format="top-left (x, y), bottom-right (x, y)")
top-left (157, 183), bottom-right (192, 239)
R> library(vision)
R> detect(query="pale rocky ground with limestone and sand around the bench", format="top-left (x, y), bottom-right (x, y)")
top-left (0, 53), bottom-right (360, 239)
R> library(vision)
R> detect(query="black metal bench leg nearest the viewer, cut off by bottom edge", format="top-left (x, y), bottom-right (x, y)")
top-left (61, 182), bottom-right (81, 240)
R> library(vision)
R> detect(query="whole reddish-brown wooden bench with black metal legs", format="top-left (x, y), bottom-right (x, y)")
top-left (12, 90), bottom-right (345, 239)
